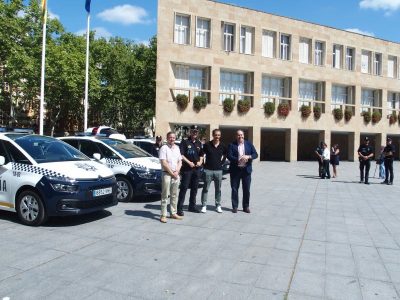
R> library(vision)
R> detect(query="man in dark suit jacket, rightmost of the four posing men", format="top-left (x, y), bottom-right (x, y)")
top-left (228, 130), bottom-right (258, 213)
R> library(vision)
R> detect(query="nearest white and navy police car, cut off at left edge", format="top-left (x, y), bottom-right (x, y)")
top-left (0, 133), bottom-right (118, 225)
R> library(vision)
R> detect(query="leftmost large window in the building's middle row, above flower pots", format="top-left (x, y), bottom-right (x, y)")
top-left (174, 64), bottom-right (209, 96)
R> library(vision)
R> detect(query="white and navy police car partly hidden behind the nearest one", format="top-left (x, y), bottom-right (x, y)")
top-left (59, 136), bottom-right (161, 202)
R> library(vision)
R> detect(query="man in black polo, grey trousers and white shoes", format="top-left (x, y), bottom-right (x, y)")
top-left (201, 129), bottom-right (227, 213)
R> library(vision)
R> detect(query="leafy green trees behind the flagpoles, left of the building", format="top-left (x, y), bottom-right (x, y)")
top-left (0, 0), bottom-right (157, 134)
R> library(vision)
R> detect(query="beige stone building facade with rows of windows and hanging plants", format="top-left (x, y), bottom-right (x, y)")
top-left (156, 0), bottom-right (400, 161)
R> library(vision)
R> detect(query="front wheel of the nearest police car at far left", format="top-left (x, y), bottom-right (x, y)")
top-left (17, 191), bottom-right (47, 226)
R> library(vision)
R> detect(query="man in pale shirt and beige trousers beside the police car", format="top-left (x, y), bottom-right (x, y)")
top-left (159, 132), bottom-right (182, 223)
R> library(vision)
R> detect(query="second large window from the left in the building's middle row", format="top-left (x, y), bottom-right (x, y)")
top-left (219, 71), bottom-right (252, 103)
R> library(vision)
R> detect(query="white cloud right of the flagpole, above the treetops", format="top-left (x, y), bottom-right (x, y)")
top-left (97, 4), bottom-right (151, 25)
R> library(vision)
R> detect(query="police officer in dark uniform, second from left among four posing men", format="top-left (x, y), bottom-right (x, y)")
top-left (178, 125), bottom-right (204, 216)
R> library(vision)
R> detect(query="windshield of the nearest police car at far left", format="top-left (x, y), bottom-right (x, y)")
top-left (7, 134), bottom-right (89, 164)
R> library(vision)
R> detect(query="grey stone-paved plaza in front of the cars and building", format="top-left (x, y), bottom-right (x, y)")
top-left (0, 162), bottom-right (400, 300)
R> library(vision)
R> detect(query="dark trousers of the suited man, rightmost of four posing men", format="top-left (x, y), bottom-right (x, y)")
top-left (230, 168), bottom-right (251, 209)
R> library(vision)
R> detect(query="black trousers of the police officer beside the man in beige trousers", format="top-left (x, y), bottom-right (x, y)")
top-left (177, 168), bottom-right (200, 212)
